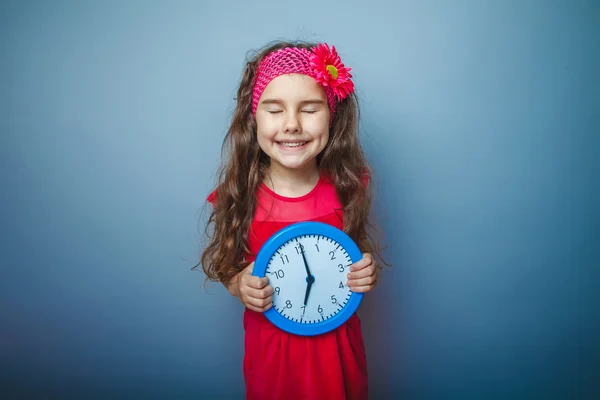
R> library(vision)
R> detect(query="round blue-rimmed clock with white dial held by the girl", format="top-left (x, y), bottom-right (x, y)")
top-left (252, 222), bottom-right (363, 336)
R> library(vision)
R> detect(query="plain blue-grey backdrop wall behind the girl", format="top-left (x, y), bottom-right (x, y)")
top-left (0, 0), bottom-right (600, 399)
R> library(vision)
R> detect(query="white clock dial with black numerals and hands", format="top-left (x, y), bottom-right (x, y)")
top-left (266, 235), bottom-right (352, 324)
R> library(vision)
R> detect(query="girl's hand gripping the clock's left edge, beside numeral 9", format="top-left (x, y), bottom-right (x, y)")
top-left (232, 262), bottom-right (273, 312)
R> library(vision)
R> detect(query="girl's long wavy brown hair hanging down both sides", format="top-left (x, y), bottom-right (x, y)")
top-left (194, 42), bottom-right (382, 283)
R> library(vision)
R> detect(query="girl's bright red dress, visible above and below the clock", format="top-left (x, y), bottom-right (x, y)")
top-left (209, 176), bottom-right (368, 400)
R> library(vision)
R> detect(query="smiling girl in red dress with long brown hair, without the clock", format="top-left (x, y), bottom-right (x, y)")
top-left (201, 42), bottom-right (386, 400)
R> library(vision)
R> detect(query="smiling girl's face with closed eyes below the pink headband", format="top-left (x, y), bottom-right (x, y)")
top-left (256, 74), bottom-right (330, 177)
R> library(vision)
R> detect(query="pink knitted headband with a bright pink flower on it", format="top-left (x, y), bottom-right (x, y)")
top-left (252, 43), bottom-right (354, 119)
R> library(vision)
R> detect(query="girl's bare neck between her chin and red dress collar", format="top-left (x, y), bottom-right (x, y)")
top-left (265, 163), bottom-right (319, 197)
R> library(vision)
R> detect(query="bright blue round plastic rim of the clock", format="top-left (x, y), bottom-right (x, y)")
top-left (252, 221), bottom-right (364, 336)
